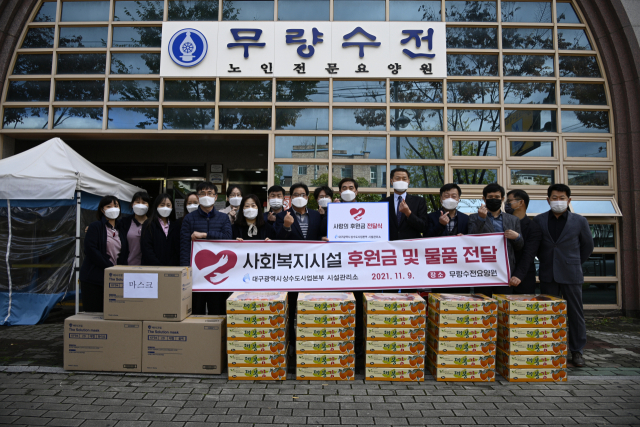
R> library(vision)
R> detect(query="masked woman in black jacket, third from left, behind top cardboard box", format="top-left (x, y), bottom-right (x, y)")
top-left (141, 193), bottom-right (180, 267)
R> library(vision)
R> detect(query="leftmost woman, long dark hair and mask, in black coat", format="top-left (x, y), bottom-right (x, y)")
top-left (80, 196), bottom-right (129, 313)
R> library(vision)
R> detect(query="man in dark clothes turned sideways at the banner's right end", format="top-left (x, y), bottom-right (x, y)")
top-left (504, 190), bottom-right (542, 294)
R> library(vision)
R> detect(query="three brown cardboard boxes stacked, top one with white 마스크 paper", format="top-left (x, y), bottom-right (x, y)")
top-left (64, 266), bottom-right (226, 374)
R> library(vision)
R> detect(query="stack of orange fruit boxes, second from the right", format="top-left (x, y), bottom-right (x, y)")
top-left (427, 293), bottom-right (498, 381)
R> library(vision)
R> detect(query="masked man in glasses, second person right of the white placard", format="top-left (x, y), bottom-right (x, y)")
top-left (427, 184), bottom-right (469, 237)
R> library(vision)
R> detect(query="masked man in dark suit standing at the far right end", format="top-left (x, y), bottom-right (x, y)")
top-left (534, 184), bottom-right (593, 367)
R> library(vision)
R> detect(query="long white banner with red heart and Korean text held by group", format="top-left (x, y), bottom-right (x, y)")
top-left (191, 233), bottom-right (510, 292)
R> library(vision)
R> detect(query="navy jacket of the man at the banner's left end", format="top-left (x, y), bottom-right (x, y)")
top-left (180, 207), bottom-right (231, 267)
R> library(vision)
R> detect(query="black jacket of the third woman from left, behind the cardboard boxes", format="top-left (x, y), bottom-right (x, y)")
top-left (140, 220), bottom-right (180, 267)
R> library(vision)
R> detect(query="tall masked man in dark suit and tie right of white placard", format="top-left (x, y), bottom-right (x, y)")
top-left (382, 168), bottom-right (427, 240)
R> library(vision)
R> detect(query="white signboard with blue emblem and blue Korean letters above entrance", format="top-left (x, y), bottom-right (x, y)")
top-left (160, 21), bottom-right (447, 79)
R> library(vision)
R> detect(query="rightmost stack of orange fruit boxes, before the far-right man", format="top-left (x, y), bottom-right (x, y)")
top-left (495, 295), bottom-right (567, 382)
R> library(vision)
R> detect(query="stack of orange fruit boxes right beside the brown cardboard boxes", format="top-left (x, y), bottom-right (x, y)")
top-left (227, 292), bottom-right (289, 381)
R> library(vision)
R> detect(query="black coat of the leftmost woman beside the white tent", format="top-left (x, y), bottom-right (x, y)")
top-left (80, 216), bottom-right (129, 286)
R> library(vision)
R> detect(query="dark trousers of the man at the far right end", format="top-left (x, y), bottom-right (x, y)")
top-left (540, 282), bottom-right (587, 353)
